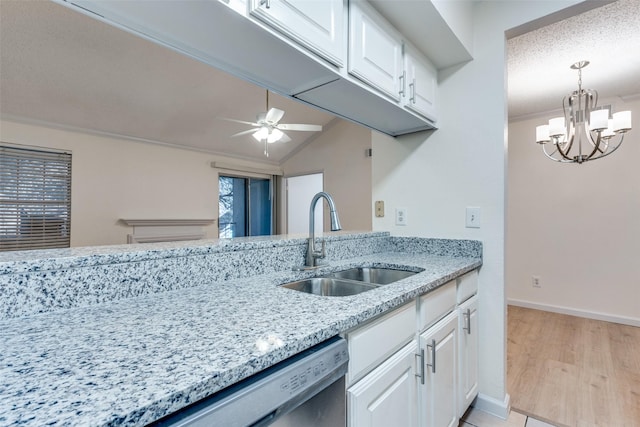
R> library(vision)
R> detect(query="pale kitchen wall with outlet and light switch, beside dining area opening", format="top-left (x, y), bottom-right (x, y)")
top-left (373, 1), bottom-right (575, 416)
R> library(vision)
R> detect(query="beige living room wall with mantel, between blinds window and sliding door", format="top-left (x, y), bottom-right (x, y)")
top-left (0, 121), bottom-right (280, 246)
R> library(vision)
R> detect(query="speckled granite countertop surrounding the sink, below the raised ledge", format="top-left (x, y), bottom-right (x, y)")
top-left (0, 252), bottom-right (481, 426)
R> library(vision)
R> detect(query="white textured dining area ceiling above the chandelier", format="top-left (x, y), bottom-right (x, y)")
top-left (507, 0), bottom-right (640, 119)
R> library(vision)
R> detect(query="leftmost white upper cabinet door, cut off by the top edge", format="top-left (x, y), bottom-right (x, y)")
top-left (251, 0), bottom-right (346, 66)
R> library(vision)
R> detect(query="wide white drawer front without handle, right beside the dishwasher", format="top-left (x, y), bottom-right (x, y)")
top-left (347, 302), bottom-right (416, 384)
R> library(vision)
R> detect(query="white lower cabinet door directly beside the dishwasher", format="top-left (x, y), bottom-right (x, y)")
top-left (347, 340), bottom-right (419, 427)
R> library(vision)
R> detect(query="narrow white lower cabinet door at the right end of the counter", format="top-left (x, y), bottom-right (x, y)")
top-left (458, 296), bottom-right (478, 416)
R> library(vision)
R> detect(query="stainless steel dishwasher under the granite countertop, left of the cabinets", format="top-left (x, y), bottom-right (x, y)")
top-left (152, 337), bottom-right (349, 427)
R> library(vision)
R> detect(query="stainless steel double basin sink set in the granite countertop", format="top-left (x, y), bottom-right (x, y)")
top-left (280, 267), bottom-right (417, 297)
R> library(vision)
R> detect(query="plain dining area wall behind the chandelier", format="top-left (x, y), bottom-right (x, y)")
top-left (506, 96), bottom-right (640, 326)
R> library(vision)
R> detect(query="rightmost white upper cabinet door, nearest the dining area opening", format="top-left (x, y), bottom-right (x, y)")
top-left (404, 46), bottom-right (438, 121)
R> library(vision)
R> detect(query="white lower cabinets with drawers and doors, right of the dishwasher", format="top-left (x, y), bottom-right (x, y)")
top-left (346, 272), bottom-right (478, 427)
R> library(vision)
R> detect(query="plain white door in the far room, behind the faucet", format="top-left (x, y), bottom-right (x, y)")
top-left (285, 173), bottom-right (324, 235)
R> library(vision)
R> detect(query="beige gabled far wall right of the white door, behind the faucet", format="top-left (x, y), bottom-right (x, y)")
top-left (282, 119), bottom-right (376, 231)
